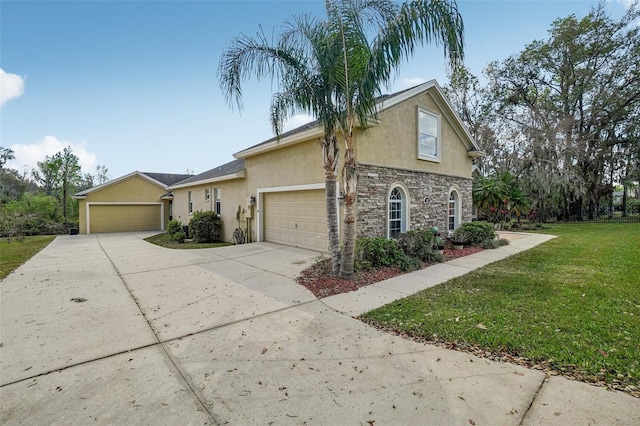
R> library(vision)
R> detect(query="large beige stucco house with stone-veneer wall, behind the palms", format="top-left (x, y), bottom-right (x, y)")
top-left (169, 80), bottom-right (483, 251)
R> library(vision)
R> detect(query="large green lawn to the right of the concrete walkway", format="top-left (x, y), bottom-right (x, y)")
top-left (362, 223), bottom-right (640, 392)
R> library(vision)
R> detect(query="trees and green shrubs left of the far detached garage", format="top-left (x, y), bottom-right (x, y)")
top-left (0, 147), bottom-right (109, 237)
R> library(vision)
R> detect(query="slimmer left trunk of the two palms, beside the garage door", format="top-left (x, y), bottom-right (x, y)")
top-left (321, 133), bottom-right (340, 275)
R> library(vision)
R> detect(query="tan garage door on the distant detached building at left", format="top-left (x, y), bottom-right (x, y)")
top-left (89, 204), bottom-right (162, 234)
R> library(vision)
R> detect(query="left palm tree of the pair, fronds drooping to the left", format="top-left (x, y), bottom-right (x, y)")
top-left (218, 16), bottom-right (340, 274)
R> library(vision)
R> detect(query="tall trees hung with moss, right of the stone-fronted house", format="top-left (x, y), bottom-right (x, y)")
top-left (445, 4), bottom-right (640, 220)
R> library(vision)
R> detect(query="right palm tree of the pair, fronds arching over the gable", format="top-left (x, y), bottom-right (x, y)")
top-left (326, 0), bottom-right (464, 278)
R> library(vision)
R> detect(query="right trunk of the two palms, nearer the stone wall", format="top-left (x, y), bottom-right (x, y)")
top-left (340, 145), bottom-right (358, 278)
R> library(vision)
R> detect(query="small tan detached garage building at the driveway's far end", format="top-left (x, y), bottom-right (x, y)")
top-left (73, 171), bottom-right (190, 234)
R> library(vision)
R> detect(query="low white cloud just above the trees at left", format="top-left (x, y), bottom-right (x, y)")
top-left (7, 136), bottom-right (97, 173)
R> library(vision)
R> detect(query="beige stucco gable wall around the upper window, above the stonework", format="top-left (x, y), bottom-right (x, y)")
top-left (357, 91), bottom-right (472, 177)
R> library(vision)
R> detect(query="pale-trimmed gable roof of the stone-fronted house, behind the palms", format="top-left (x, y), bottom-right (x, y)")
top-left (233, 80), bottom-right (482, 158)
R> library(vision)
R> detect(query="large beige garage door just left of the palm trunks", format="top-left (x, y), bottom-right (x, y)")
top-left (263, 189), bottom-right (328, 252)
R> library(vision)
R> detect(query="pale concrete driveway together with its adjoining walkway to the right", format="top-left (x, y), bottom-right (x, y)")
top-left (0, 234), bottom-right (640, 425)
